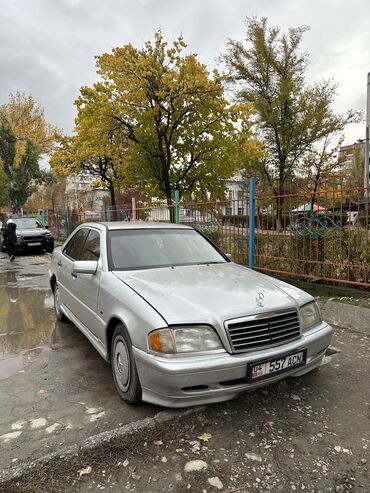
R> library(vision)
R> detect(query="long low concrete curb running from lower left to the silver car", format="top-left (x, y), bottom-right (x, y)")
top-left (0, 406), bottom-right (205, 486)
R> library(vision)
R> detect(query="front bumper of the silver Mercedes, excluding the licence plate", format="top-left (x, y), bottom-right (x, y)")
top-left (133, 322), bottom-right (333, 407)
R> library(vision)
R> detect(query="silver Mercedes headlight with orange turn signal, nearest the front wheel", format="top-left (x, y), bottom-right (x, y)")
top-left (149, 325), bottom-right (222, 354)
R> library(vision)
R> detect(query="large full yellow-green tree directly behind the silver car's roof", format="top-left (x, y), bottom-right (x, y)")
top-left (94, 31), bottom-right (253, 211)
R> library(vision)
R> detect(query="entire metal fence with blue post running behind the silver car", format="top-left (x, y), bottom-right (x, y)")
top-left (2, 179), bottom-right (370, 288)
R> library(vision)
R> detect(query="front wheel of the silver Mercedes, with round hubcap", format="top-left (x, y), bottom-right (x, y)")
top-left (111, 324), bottom-right (142, 404)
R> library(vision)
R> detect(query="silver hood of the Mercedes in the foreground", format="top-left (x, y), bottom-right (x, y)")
top-left (114, 262), bottom-right (312, 326)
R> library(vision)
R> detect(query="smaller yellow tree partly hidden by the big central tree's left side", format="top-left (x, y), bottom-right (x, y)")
top-left (50, 84), bottom-right (126, 215)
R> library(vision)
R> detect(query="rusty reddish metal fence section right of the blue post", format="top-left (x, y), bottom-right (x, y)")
top-left (255, 184), bottom-right (370, 287)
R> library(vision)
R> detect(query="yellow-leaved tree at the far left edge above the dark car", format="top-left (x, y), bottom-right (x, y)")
top-left (0, 92), bottom-right (57, 210)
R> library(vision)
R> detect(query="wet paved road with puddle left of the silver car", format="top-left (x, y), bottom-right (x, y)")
top-left (0, 254), bottom-right (158, 468)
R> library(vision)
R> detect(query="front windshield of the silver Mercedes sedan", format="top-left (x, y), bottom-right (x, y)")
top-left (108, 228), bottom-right (226, 270)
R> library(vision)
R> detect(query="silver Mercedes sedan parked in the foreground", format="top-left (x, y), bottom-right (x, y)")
top-left (50, 222), bottom-right (332, 407)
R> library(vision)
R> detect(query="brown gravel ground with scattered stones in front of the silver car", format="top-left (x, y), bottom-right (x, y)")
top-left (0, 322), bottom-right (370, 493)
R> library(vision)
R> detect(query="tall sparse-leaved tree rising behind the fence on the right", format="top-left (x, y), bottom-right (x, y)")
top-left (222, 17), bottom-right (358, 227)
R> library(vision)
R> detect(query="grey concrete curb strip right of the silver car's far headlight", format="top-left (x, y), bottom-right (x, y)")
top-left (319, 299), bottom-right (370, 336)
